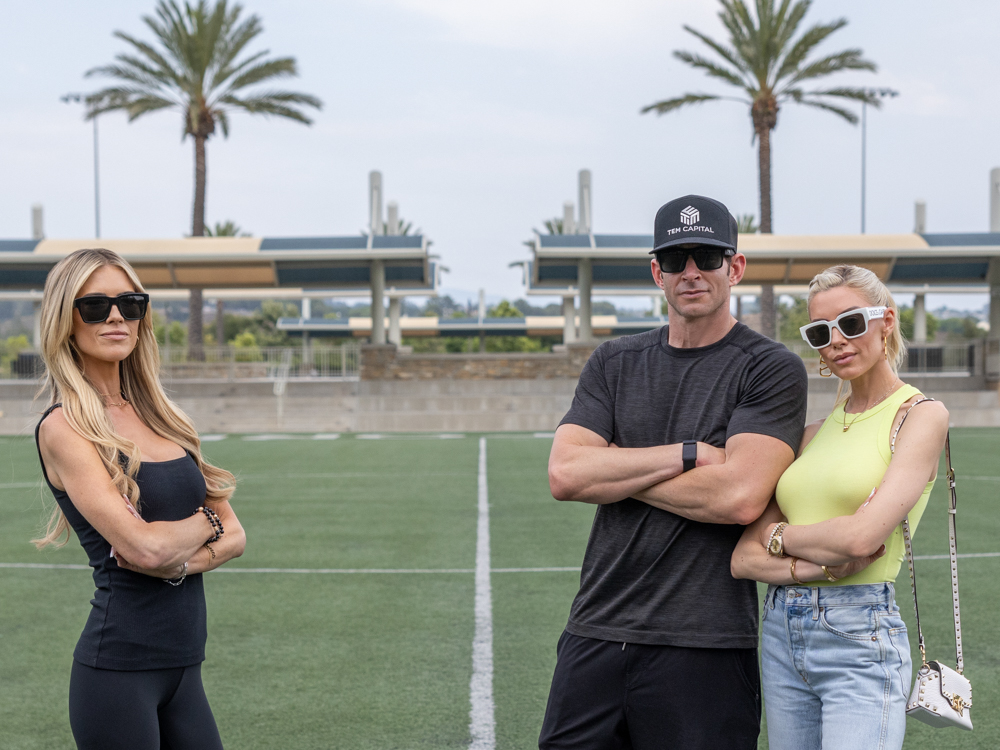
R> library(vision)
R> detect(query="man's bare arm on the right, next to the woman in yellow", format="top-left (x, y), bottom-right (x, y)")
top-left (632, 432), bottom-right (795, 526)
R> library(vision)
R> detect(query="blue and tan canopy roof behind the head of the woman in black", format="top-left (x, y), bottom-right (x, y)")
top-left (0, 235), bottom-right (437, 295)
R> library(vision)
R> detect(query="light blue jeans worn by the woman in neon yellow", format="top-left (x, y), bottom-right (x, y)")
top-left (761, 583), bottom-right (912, 750)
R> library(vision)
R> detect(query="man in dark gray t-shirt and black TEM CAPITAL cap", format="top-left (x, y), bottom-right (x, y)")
top-left (539, 196), bottom-right (807, 750)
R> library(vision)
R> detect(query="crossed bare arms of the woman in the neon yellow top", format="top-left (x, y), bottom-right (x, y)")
top-left (732, 402), bottom-right (948, 584)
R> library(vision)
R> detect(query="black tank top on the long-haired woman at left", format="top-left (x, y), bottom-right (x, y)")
top-left (35, 404), bottom-right (208, 671)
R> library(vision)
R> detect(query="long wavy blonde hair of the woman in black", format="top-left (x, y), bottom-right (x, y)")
top-left (32, 249), bottom-right (236, 549)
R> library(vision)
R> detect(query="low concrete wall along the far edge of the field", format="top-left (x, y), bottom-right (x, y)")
top-left (0, 377), bottom-right (1000, 435)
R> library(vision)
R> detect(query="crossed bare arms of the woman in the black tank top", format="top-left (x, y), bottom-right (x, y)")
top-left (39, 409), bottom-right (246, 578)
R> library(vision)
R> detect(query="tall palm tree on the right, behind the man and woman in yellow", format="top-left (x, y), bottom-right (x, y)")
top-left (641, 0), bottom-right (881, 338)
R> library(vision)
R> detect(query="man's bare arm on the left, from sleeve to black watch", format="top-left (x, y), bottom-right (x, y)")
top-left (549, 424), bottom-right (683, 505)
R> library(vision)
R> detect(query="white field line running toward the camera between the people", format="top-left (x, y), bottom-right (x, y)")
top-left (469, 438), bottom-right (496, 750)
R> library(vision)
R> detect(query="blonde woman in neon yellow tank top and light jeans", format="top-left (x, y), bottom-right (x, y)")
top-left (732, 266), bottom-right (948, 750)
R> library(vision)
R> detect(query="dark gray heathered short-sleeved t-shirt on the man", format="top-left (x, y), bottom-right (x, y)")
top-left (561, 323), bottom-right (807, 648)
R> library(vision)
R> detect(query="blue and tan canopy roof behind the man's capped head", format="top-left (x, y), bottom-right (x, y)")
top-left (525, 233), bottom-right (1000, 295)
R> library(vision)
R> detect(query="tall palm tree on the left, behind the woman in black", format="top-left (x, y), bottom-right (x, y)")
top-left (86, 0), bottom-right (322, 356)
